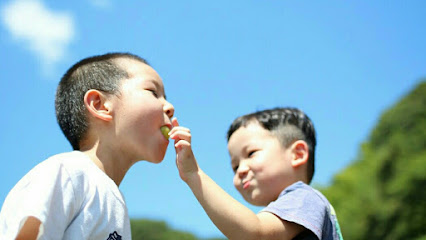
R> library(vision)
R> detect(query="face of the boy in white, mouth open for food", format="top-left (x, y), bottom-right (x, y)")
top-left (113, 59), bottom-right (174, 163)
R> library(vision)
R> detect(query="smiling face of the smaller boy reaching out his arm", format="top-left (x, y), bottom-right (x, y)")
top-left (228, 121), bottom-right (294, 206)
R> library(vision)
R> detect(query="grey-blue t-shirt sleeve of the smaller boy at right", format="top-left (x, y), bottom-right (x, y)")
top-left (261, 188), bottom-right (329, 239)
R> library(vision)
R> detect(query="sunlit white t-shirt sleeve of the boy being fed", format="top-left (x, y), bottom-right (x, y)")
top-left (0, 159), bottom-right (78, 238)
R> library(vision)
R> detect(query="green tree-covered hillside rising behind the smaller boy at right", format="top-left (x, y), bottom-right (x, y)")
top-left (322, 81), bottom-right (426, 240)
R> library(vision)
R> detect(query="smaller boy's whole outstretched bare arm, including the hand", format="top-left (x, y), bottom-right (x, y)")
top-left (170, 118), bottom-right (304, 240)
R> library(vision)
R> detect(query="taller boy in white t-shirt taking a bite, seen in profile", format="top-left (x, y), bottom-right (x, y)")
top-left (0, 53), bottom-right (174, 240)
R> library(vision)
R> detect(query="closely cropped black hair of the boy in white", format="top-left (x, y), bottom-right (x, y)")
top-left (55, 52), bottom-right (149, 150)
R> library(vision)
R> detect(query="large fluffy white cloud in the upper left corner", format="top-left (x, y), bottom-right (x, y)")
top-left (1, 0), bottom-right (74, 74)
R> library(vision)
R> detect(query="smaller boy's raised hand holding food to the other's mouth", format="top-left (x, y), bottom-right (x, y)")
top-left (169, 118), bottom-right (199, 182)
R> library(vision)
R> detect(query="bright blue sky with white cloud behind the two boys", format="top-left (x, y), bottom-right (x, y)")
top-left (0, 0), bottom-right (426, 237)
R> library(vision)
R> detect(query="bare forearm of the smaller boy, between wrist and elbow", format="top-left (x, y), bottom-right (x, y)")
top-left (186, 170), bottom-right (262, 240)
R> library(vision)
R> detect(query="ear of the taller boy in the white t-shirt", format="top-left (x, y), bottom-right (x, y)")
top-left (84, 89), bottom-right (112, 121)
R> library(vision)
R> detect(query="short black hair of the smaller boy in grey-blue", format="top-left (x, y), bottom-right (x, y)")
top-left (227, 107), bottom-right (316, 183)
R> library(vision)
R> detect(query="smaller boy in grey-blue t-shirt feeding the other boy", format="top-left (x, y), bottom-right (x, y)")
top-left (170, 108), bottom-right (343, 240)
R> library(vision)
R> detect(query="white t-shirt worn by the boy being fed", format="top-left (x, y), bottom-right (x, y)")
top-left (0, 151), bottom-right (131, 240)
